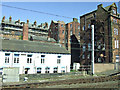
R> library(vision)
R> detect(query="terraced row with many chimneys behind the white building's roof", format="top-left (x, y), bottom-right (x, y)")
top-left (0, 16), bottom-right (55, 42)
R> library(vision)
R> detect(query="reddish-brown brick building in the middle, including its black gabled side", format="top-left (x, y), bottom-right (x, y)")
top-left (48, 18), bottom-right (80, 66)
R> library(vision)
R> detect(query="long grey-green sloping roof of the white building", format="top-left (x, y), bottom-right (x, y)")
top-left (0, 39), bottom-right (70, 54)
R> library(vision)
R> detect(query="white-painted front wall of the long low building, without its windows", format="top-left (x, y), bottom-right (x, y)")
top-left (0, 52), bottom-right (71, 74)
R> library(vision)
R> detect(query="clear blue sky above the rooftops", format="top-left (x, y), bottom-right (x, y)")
top-left (1, 2), bottom-right (118, 25)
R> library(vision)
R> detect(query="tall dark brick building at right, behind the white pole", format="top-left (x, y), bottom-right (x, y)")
top-left (80, 3), bottom-right (120, 64)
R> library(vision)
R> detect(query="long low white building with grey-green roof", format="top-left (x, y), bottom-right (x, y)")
top-left (0, 39), bottom-right (71, 74)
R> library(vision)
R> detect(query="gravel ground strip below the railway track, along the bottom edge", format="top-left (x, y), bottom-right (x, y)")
top-left (42, 81), bottom-right (120, 88)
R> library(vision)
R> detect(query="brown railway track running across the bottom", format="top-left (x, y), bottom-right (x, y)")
top-left (2, 72), bottom-right (120, 89)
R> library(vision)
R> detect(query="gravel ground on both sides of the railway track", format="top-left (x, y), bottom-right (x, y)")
top-left (3, 71), bottom-right (120, 88)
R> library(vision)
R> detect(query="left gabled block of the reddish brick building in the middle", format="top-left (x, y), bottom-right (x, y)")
top-left (48, 20), bottom-right (66, 47)
